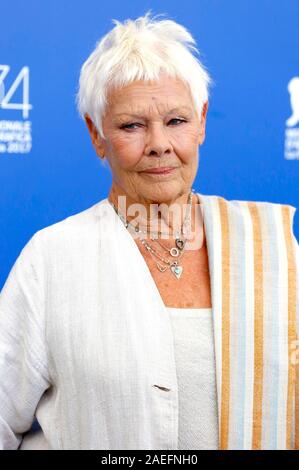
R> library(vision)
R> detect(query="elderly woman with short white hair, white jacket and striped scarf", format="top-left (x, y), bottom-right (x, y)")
top-left (0, 14), bottom-right (299, 450)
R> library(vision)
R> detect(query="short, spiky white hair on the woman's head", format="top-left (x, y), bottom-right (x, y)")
top-left (76, 10), bottom-right (212, 138)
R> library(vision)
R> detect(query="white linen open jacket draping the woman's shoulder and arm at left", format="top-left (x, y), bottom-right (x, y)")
top-left (0, 199), bottom-right (220, 450)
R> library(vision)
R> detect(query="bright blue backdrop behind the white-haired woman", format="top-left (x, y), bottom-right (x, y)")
top-left (0, 0), bottom-right (299, 289)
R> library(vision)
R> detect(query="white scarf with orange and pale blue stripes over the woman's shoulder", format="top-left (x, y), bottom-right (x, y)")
top-left (198, 193), bottom-right (299, 450)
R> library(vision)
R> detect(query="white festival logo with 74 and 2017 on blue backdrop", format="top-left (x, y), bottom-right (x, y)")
top-left (0, 65), bottom-right (32, 154)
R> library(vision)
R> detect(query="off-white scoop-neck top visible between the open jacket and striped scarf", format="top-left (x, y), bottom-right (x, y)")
top-left (168, 308), bottom-right (218, 450)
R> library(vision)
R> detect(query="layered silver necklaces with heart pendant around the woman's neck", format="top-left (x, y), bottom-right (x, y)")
top-left (108, 188), bottom-right (195, 279)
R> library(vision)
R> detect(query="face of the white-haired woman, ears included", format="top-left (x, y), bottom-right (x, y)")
top-left (86, 76), bottom-right (208, 204)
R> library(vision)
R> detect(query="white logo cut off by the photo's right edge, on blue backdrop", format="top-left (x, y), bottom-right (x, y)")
top-left (284, 77), bottom-right (299, 160)
